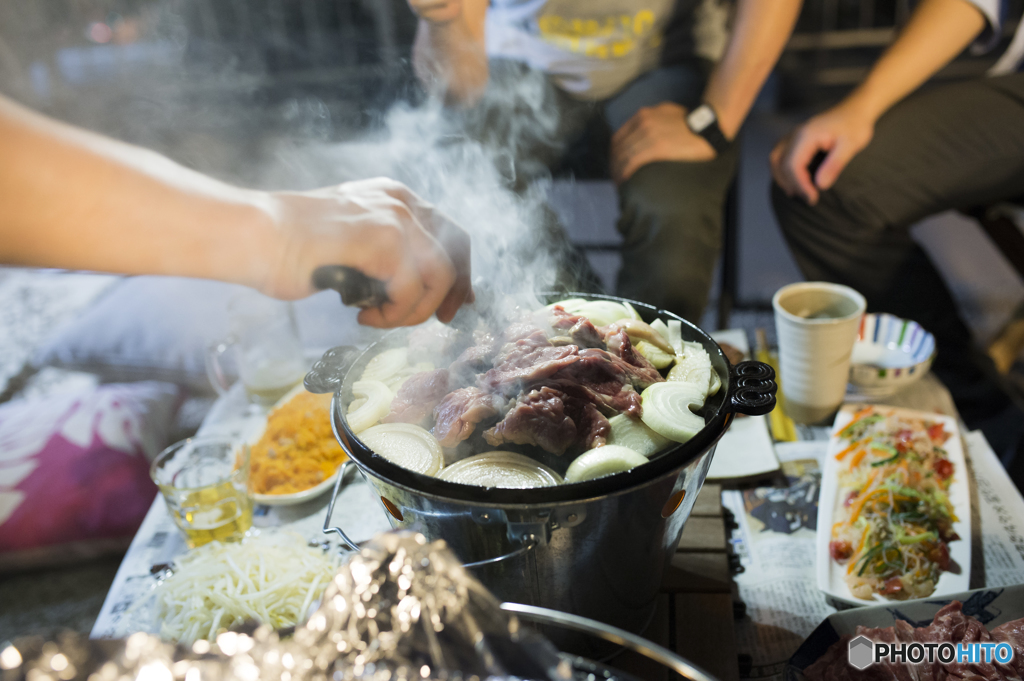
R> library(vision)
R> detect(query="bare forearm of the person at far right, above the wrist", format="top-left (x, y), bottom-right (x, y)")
top-left (844, 0), bottom-right (985, 121)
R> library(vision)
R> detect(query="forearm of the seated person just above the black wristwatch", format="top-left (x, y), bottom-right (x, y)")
top-left (705, 0), bottom-right (802, 139)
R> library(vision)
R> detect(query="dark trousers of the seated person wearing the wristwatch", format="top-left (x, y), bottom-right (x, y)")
top-left (467, 61), bottom-right (736, 323)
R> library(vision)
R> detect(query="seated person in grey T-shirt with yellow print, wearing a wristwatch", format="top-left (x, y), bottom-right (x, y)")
top-left (410, 0), bottom-right (801, 322)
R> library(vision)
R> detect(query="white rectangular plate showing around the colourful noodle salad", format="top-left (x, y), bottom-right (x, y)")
top-left (815, 405), bottom-right (971, 605)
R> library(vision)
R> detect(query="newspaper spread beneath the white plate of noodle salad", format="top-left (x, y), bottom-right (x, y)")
top-left (722, 432), bottom-right (1024, 680)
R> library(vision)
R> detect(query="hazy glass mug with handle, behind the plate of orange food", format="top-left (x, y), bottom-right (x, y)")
top-left (207, 292), bottom-right (307, 407)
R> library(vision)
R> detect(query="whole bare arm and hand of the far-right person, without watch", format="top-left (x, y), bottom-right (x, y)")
top-left (771, 0), bottom-right (985, 204)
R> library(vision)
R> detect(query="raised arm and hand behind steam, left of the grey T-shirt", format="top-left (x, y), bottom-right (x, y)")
top-left (409, 0), bottom-right (488, 104)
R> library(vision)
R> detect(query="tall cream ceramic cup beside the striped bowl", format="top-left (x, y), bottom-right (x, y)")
top-left (772, 282), bottom-right (866, 423)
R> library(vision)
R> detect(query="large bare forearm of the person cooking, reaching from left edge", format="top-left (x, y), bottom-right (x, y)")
top-left (0, 97), bottom-right (276, 288)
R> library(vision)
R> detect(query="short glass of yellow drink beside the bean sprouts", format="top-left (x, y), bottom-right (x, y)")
top-left (150, 437), bottom-right (253, 548)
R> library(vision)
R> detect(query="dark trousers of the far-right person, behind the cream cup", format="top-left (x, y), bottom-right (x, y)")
top-left (772, 74), bottom-right (1024, 454)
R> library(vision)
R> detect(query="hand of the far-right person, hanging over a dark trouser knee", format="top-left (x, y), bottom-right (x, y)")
top-left (770, 102), bottom-right (874, 206)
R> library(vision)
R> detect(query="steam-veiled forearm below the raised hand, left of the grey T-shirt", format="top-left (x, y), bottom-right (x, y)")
top-left (413, 14), bottom-right (488, 104)
